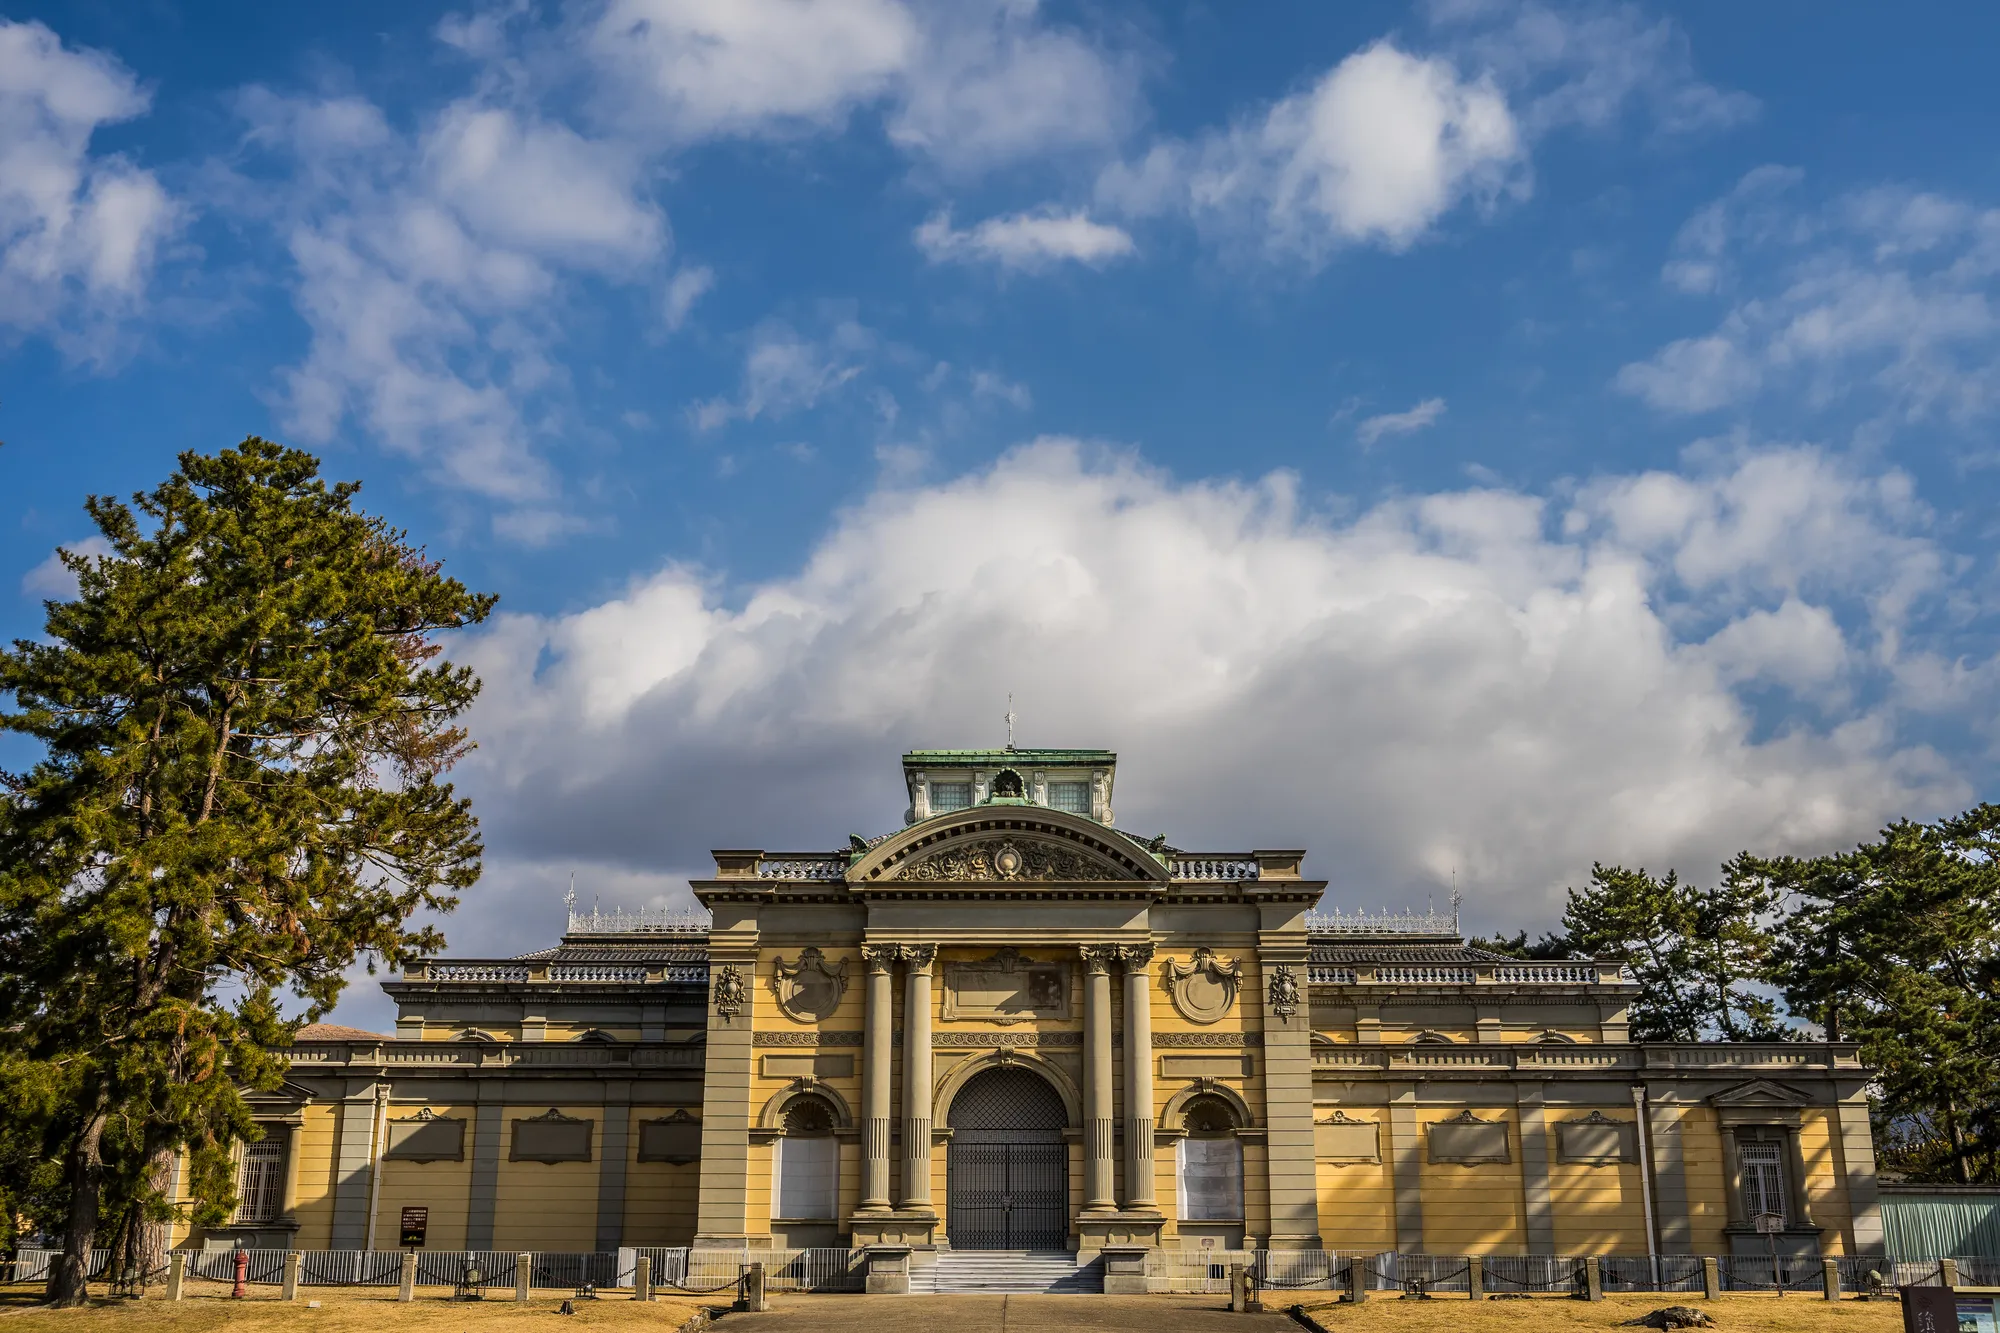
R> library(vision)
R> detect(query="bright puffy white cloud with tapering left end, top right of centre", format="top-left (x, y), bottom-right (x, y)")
top-left (1098, 42), bottom-right (1524, 262)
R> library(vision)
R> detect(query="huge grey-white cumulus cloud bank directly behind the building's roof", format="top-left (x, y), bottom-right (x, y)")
top-left (430, 440), bottom-right (1968, 964)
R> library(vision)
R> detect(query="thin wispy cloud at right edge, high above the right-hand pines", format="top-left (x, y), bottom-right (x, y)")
top-left (1616, 166), bottom-right (2000, 422)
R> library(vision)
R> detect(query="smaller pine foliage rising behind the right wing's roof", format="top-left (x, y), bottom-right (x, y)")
top-left (1562, 865), bottom-right (1790, 1041)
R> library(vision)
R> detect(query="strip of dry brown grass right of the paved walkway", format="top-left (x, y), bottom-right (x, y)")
top-left (1296, 1291), bottom-right (1902, 1333)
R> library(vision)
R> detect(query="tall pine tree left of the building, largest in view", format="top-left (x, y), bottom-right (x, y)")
top-left (0, 438), bottom-right (494, 1305)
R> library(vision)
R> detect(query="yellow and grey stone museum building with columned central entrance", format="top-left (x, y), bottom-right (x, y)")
top-left (203, 749), bottom-right (1882, 1265)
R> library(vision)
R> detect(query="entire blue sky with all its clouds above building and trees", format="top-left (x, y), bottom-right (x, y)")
top-left (0, 0), bottom-right (2000, 1017)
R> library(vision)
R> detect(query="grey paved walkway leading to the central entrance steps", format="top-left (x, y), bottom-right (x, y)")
top-left (716, 1295), bottom-right (1298, 1333)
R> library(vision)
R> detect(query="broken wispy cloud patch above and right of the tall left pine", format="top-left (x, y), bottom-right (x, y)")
top-left (240, 88), bottom-right (668, 520)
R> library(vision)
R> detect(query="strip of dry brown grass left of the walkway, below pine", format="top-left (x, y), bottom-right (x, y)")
top-left (0, 1283), bottom-right (712, 1333)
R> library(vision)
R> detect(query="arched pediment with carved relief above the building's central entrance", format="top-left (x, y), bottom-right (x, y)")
top-left (848, 807), bottom-right (1168, 885)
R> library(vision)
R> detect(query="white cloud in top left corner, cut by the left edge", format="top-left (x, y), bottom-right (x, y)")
top-left (0, 20), bottom-right (182, 358)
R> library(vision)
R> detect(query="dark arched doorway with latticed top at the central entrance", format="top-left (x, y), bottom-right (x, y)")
top-left (944, 1067), bottom-right (1070, 1249)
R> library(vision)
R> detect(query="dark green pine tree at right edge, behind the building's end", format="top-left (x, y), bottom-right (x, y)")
top-left (1730, 805), bottom-right (2000, 1183)
